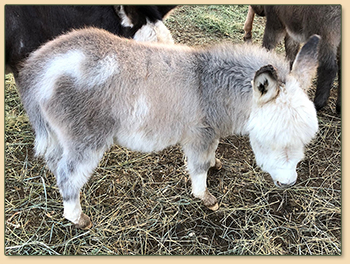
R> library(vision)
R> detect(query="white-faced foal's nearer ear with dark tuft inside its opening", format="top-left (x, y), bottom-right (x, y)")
top-left (252, 65), bottom-right (279, 103)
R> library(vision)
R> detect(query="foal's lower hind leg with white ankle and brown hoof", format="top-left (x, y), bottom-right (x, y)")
top-left (56, 150), bottom-right (103, 229)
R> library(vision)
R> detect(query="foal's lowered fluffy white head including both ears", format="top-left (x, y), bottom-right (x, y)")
top-left (248, 35), bottom-right (320, 187)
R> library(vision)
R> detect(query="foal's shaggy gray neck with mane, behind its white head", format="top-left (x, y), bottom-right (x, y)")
top-left (197, 44), bottom-right (289, 136)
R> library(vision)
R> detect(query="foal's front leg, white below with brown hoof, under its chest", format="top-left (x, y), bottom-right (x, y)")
top-left (184, 137), bottom-right (220, 211)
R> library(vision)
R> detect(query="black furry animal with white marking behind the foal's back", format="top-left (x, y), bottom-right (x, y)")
top-left (5, 5), bottom-right (175, 78)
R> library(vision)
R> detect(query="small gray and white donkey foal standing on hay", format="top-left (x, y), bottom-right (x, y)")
top-left (18, 28), bottom-right (319, 228)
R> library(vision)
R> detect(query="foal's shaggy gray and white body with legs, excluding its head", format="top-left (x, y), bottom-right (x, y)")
top-left (18, 29), bottom-right (318, 228)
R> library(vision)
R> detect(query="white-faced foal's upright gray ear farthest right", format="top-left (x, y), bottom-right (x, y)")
top-left (291, 35), bottom-right (321, 90)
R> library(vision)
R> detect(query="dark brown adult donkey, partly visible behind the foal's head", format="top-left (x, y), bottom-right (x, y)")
top-left (244, 5), bottom-right (341, 113)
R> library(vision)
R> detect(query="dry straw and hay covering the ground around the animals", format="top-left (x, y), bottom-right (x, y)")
top-left (5, 6), bottom-right (341, 255)
